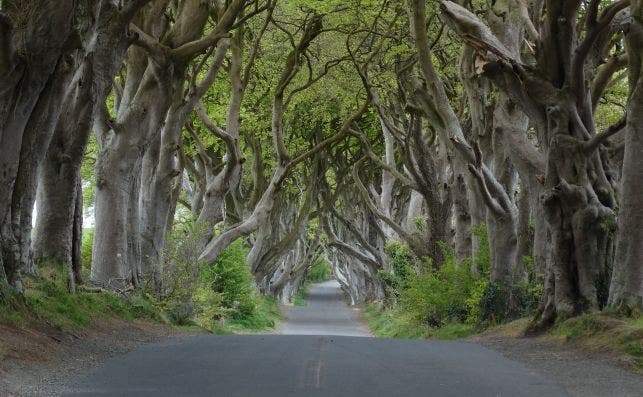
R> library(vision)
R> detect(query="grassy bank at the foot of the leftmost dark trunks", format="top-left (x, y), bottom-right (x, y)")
top-left (0, 268), bottom-right (165, 331)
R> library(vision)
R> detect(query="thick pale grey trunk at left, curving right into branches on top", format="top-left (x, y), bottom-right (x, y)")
top-left (91, 0), bottom-right (244, 288)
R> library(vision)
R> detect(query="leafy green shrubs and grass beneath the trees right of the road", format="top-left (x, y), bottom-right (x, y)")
top-left (372, 224), bottom-right (542, 337)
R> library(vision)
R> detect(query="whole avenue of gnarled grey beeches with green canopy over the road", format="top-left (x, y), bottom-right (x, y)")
top-left (0, 0), bottom-right (643, 332)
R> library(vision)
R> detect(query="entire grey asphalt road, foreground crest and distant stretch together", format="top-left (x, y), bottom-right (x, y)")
top-left (65, 283), bottom-right (567, 397)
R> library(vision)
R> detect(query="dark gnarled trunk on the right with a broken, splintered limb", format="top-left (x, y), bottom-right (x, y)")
top-left (442, 1), bottom-right (629, 331)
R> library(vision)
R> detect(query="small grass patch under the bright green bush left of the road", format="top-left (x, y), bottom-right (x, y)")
top-left (211, 296), bottom-right (283, 335)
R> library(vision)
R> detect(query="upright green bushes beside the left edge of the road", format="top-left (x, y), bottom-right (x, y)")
top-left (158, 221), bottom-right (281, 333)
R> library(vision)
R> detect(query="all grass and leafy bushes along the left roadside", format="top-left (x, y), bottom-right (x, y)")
top-left (0, 225), bottom-right (282, 333)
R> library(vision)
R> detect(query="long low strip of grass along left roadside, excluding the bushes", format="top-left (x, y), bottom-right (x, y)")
top-left (0, 266), bottom-right (283, 334)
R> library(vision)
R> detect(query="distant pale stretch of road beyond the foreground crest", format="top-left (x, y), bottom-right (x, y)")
top-left (277, 281), bottom-right (370, 337)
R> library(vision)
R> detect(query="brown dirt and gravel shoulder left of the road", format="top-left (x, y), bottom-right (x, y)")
top-left (0, 319), bottom-right (190, 396)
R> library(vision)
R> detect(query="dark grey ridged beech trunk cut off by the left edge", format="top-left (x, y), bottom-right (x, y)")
top-left (0, 0), bottom-right (76, 290)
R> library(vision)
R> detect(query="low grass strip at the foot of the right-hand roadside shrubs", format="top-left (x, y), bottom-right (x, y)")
top-left (362, 304), bottom-right (475, 339)
